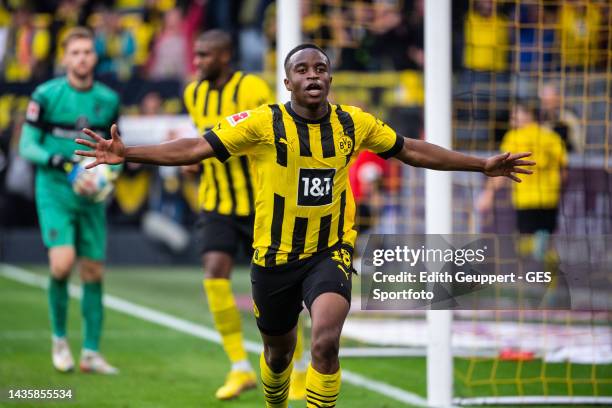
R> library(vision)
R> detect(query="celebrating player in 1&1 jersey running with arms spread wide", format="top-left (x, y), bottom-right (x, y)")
top-left (77, 44), bottom-right (533, 407)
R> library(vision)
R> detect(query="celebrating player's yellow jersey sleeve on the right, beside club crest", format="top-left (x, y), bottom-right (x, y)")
top-left (355, 111), bottom-right (404, 159)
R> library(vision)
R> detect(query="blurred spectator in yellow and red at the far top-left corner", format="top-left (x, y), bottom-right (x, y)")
top-left (4, 7), bottom-right (50, 82)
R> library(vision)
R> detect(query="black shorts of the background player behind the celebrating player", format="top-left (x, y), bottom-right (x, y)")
top-left (196, 211), bottom-right (254, 259)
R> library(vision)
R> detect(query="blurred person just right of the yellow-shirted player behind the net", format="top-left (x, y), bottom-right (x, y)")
top-left (539, 82), bottom-right (586, 153)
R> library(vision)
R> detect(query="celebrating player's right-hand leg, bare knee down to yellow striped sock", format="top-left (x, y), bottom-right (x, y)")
top-left (306, 293), bottom-right (350, 407)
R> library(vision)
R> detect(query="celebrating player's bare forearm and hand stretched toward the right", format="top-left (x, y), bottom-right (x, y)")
top-left (395, 138), bottom-right (535, 183)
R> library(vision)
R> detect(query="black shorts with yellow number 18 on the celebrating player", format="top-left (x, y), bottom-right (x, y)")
top-left (251, 245), bottom-right (354, 336)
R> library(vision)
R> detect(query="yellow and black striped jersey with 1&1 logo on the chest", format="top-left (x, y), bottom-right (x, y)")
top-left (204, 104), bottom-right (404, 266)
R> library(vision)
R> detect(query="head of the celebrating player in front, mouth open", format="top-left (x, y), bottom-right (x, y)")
top-left (285, 48), bottom-right (332, 106)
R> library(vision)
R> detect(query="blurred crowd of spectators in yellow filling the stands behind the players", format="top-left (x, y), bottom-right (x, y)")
top-left (0, 0), bottom-right (612, 236)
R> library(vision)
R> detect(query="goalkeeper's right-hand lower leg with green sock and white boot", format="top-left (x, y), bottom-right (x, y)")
top-left (79, 258), bottom-right (119, 374)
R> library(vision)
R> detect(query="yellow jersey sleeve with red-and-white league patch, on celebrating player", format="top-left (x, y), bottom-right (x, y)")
top-left (204, 109), bottom-right (262, 162)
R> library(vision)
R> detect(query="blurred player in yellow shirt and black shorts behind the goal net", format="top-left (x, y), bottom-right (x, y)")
top-left (478, 101), bottom-right (567, 260)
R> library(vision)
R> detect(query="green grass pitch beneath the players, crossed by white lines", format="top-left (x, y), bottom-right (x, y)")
top-left (0, 266), bottom-right (612, 408)
